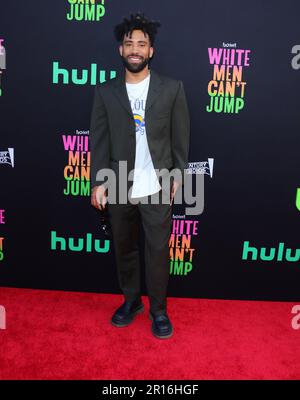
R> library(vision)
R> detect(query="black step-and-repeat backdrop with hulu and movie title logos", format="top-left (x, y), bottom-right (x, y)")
top-left (0, 0), bottom-right (300, 301)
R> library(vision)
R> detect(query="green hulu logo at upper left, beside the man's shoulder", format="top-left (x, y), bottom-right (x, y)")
top-left (52, 61), bottom-right (116, 85)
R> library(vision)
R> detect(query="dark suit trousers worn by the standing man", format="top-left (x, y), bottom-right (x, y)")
top-left (108, 190), bottom-right (172, 314)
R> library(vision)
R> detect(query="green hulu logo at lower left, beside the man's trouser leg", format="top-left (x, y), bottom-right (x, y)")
top-left (51, 231), bottom-right (110, 253)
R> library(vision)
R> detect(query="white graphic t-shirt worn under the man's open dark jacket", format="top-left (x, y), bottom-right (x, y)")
top-left (126, 74), bottom-right (161, 197)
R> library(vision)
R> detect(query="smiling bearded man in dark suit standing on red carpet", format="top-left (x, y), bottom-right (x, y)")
top-left (90, 13), bottom-right (190, 339)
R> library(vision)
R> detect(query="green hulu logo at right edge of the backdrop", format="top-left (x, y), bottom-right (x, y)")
top-left (242, 242), bottom-right (300, 262)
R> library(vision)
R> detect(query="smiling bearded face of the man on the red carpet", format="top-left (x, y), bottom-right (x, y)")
top-left (119, 29), bottom-right (154, 73)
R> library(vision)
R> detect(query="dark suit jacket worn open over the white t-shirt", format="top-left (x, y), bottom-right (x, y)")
top-left (90, 69), bottom-right (190, 188)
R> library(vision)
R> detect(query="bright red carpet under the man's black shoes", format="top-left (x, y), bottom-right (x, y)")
top-left (0, 288), bottom-right (300, 380)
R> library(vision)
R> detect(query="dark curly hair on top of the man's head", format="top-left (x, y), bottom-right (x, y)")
top-left (114, 12), bottom-right (161, 46)
